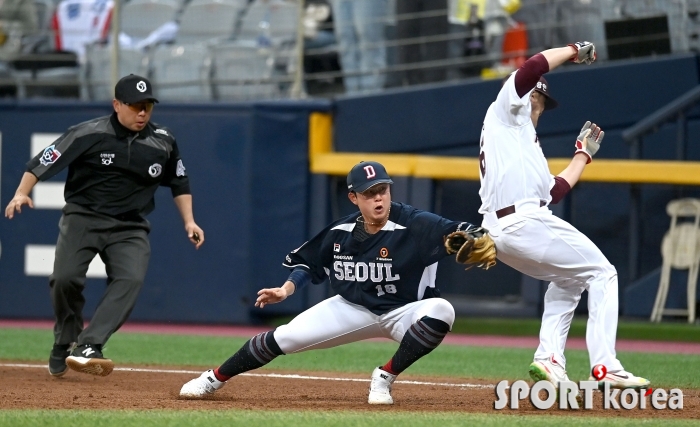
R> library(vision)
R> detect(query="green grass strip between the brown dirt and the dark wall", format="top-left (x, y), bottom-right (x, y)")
top-left (0, 329), bottom-right (700, 388)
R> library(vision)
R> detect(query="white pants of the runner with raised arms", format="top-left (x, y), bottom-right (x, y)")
top-left (484, 205), bottom-right (622, 371)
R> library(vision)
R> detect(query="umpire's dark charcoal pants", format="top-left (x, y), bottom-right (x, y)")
top-left (49, 203), bottom-right (151, 345)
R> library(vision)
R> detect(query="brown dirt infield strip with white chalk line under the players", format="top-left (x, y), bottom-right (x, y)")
top-left (0, 361), bottom-right (700, 419)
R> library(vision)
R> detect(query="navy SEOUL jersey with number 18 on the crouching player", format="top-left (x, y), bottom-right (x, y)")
top-left (283, 202), bottom-right (471, 315)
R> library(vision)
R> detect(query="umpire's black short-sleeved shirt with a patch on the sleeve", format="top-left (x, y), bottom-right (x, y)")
top-left (27, 113), bottom-right (190, 216)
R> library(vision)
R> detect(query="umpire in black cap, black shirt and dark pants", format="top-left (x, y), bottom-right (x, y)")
top-left (5, 74), bottom-right (204, 377)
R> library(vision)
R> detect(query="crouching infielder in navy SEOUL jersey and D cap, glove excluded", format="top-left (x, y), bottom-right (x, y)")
top-left (180, 162), bottom-right (490, 405)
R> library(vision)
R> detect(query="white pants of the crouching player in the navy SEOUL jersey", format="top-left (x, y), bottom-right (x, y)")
top-left (275, 295), bottom-right (455, 354)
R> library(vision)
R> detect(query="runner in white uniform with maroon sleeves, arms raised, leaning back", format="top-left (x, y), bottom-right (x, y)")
top-left (479, 42), bottom-right (649, 388)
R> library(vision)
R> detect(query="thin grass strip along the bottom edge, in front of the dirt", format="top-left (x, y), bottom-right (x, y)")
top-left (0, 408), bottom-right (697, 427)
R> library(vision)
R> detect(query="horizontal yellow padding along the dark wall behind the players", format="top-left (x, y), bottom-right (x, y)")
top-left (311, 152), bottom-right (700, 185)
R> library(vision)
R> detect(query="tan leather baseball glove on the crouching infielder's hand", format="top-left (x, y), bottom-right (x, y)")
top-left (445, 227), bottom-right (496, 270)
